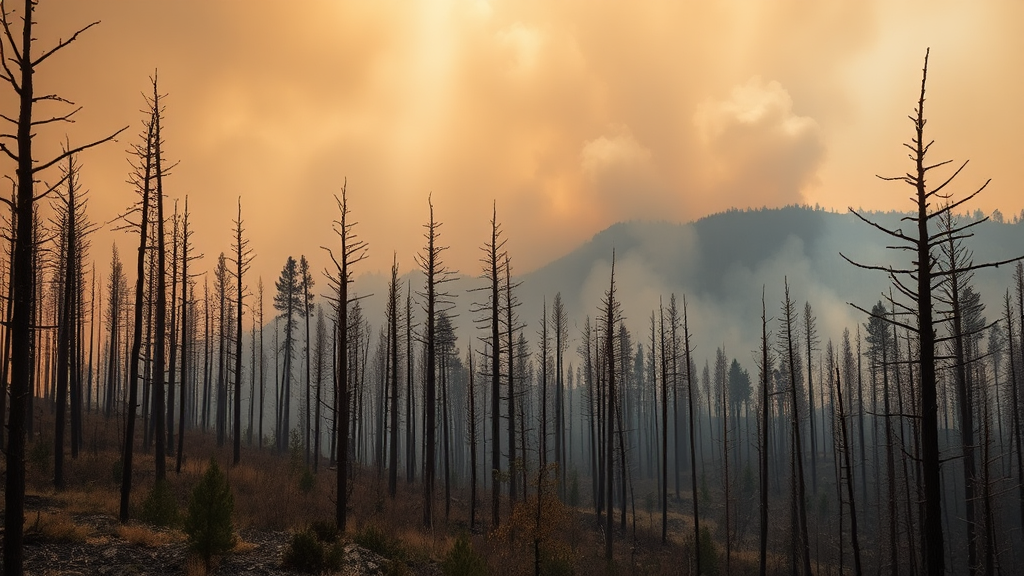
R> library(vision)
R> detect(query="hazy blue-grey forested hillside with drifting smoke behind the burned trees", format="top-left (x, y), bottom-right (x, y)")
top-left (346, 207), bottom-right (1024, 366)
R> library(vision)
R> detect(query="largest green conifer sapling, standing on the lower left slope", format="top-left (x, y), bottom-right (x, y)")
top-left (184, 458), bottom-right (236, 568)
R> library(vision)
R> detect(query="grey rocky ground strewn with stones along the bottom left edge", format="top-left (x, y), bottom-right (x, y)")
top-left (12, 497), bottom-right (423, 576)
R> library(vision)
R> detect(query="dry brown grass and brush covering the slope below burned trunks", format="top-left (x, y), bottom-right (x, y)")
top-left (8, 402), bottom-right (781, 576)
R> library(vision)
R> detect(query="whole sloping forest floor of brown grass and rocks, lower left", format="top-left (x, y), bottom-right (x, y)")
top-left (0, 401), bottom-right (784, 576)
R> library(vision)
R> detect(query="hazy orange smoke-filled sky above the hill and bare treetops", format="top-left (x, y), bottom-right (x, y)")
top-left (16, 0), bottom-right (1024, 284)
